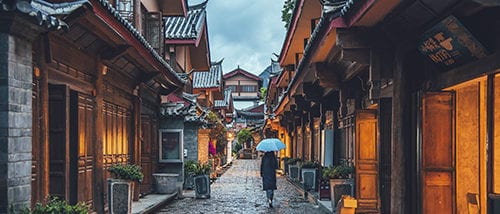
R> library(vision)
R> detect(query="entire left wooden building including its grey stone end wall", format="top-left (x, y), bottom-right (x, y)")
top-left (0, 0), bottom-right (186, 213)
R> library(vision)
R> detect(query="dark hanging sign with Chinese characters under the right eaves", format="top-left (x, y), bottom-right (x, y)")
top-left (418, 16), bottom-right (487, 69)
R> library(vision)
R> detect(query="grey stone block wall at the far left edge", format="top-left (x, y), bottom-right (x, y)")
top-left (0, 32), bottom-right (33, 213)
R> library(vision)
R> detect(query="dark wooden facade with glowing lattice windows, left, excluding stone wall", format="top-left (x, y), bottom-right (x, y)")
top-left (0, 0), bottom-right (184, 213)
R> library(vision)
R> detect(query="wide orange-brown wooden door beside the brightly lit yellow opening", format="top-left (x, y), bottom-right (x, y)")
top-left (421, 92), bottom-right (455, 214)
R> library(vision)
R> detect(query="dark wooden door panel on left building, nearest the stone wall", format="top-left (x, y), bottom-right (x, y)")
top-left (48, 85), bottom-right (69, 200)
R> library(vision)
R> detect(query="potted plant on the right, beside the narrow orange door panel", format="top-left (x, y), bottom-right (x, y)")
top-left (323, 163), bottom-right (354, 208)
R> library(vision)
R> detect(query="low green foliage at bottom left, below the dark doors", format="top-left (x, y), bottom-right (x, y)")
top-left (19, 197), bottom-right (89, 214)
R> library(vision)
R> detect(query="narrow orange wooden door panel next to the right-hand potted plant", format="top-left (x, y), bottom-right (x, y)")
top-left (355, 110), bottom-right (380, 213)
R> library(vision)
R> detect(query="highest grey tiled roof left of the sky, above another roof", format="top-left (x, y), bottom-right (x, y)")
top-left (165, 1), bottom-right (208, 40)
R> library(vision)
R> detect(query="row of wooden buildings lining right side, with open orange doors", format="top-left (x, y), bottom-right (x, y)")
top-left (266, 0), bottom-right (500, 213)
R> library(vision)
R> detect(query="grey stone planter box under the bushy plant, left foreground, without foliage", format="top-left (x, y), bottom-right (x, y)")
top-left (108, 179), bottom-right (134, 214)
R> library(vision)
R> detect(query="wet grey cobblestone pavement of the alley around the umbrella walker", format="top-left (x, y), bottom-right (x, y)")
top-left (159, 159), bottom-right (325, 214)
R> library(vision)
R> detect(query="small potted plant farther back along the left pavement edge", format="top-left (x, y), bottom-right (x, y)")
top-left (193, 163), bottom-right (212, 198)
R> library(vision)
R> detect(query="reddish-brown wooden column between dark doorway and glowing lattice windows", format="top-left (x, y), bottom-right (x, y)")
top-left (93, 60), bottom-right (108, 213)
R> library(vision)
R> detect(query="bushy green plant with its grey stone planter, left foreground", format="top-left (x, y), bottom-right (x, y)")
top-left (108, 164), bottom-right (144, 213)
